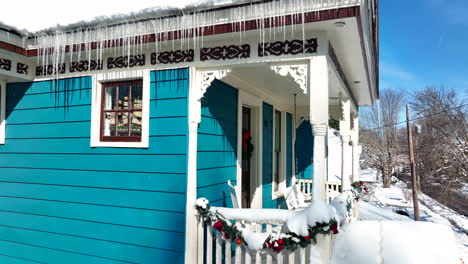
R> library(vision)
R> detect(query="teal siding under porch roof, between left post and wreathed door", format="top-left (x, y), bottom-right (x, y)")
top-left (197, 80), bottom-right (238, 207)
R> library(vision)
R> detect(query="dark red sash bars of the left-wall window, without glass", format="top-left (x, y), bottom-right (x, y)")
top-left (100, 79), bottom-right (143, 142)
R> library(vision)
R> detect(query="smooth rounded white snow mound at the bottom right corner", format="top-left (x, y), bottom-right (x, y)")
top-left (331, 221), bottom-right (460, 264)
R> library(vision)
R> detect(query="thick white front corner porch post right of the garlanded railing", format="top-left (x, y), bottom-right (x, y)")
top-left (308, 56), bottom-right (331, 264)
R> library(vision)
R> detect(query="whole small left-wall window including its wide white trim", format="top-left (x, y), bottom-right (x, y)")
top-left (90, 70), bottom-right (150, 148)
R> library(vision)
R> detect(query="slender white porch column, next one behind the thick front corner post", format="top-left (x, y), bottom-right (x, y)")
top-left (340, 96), bottom-right (352, 192)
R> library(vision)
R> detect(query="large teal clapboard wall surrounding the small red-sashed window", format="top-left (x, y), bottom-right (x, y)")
top-left (0, 69), bottom-right (189, 264)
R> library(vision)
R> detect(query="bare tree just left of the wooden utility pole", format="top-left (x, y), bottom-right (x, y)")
top-left (359, 89), bottom-right (405, 188)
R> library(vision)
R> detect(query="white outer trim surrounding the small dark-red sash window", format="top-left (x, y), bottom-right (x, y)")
top-left (90, 69), bottom-right (151, 148)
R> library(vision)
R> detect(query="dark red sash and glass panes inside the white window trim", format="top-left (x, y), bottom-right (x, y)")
top-left (101, 80), bottom-right (143, 142)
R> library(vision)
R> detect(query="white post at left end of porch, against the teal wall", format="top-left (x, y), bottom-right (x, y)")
top-left (185, 68), bottom-right (201, 263)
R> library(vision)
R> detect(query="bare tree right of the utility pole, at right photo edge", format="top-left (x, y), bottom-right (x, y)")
top-left (410, 87), bottom-right (468, 210)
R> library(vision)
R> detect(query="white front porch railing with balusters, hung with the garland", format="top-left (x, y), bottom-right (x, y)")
top-left (197, 208), bottom-right (313, 264)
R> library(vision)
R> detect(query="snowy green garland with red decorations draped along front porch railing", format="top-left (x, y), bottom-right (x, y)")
top-left (196, 198), bottom-right (338, 253)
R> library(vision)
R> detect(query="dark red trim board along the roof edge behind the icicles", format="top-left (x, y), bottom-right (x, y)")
top-left (0, 6), bottom-right (359, 57)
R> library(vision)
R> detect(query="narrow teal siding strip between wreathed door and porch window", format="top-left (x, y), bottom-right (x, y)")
top-left (262, 103), bottom-right (276, 208)
